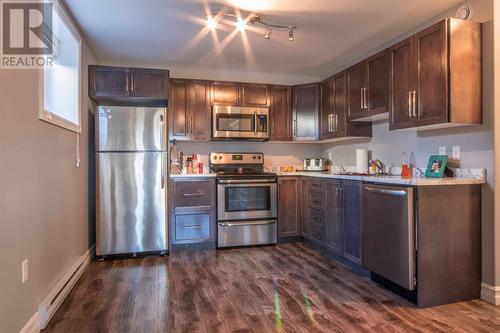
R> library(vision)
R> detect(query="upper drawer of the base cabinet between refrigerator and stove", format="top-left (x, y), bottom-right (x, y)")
top-left (173, 180), bottom-right (215, 207)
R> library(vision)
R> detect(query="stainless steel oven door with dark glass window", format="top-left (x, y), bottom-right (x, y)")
top-left (217, 179), bottom-right (277, 221)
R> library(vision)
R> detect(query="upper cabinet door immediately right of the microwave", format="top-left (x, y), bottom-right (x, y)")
top-left (269, 86), bottom-right (292, 141)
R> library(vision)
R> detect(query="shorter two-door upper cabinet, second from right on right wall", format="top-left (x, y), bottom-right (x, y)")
top-left (346, 50), bottom-right (389, 121)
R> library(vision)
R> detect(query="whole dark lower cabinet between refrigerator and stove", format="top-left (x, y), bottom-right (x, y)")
top-left (170, 178), bottom-right (215, 251)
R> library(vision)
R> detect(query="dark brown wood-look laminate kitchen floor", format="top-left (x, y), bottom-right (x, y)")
top-left (45, 243), bottom-right (500, 333)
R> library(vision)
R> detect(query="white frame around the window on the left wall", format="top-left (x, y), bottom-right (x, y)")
top-left (38, 0), bottom-right (82, 133)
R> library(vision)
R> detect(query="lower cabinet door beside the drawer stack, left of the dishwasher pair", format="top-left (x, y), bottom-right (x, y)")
top-left (326, 180), bottom-right (342, 255)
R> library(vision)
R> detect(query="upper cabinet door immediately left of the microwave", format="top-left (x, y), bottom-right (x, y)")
top-left (189, 81), bottom-right (212, 141)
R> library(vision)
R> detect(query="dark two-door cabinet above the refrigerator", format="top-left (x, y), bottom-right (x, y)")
top-left (89, 65), bottom-right (169, 106)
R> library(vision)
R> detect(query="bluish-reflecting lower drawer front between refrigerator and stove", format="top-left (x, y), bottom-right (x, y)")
top-left (174, 213), bottom-right (210, 244)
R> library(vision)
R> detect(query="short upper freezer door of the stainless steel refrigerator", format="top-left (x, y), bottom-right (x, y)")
top-left (96, 106), bottom-right (166, 152)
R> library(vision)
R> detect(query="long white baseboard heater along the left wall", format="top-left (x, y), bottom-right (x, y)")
top-left (37, 247), bottom-right (95, 329)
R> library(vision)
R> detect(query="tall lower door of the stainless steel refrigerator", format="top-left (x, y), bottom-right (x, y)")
top-left (96, 152), bottom-right (167, 255)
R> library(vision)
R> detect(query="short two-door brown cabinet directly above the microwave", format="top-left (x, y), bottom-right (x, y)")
top-left (212, 81), bottom-right (270, 107)
